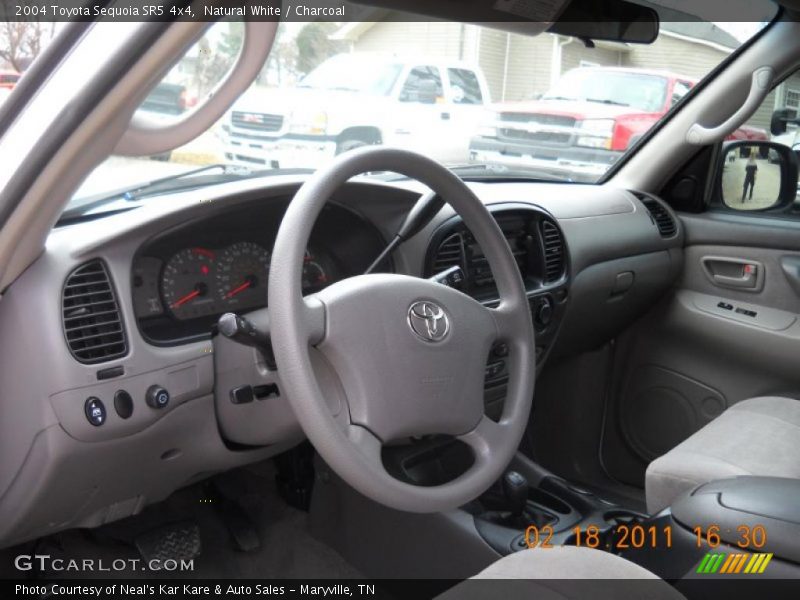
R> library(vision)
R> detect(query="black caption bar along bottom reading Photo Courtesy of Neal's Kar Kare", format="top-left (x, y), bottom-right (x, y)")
top-left (0, 578), bottom-right (800, 600)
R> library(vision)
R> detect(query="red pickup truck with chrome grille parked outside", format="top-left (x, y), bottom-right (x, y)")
top-left (469, 67), bottom-right (769, 182)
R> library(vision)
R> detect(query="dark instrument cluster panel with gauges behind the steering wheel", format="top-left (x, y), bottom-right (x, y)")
top-left (131, 198), bottom-right (391, 344)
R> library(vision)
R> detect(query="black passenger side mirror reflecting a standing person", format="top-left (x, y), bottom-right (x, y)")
top-left (718, 141), bottom-right (797, 211)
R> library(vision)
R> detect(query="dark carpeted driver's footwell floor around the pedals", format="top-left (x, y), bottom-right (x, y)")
top-left (4, 464), bottom-right (364, 579)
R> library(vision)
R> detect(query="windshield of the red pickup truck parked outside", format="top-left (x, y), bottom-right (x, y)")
top-left (543, 68), bottom-right (669, 113)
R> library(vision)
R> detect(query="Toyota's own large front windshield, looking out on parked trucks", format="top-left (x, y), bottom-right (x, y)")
top-left (0, 5), bottom-right (775, 211)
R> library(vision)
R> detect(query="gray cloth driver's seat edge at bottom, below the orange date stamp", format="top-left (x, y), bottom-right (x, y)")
top-left (437, 546), bottom-right (684, 600)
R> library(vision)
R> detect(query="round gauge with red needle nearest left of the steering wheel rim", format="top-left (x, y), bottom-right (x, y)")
top-left (217, 242), bottom-right (270, 310)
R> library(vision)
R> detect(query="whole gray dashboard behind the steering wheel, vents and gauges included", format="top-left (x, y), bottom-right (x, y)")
top-left (0, 175), bottom-right (683, 545)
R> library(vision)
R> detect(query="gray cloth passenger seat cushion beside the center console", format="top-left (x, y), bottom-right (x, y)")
top-left (645, 396), bottom-right (800, 513)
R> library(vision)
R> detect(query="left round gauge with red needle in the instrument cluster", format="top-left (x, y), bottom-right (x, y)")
top-left (161, 248), bottom-right (215, 319)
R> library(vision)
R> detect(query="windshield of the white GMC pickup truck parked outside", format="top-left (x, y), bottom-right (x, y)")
top-left (297, 54), bottom-right (402, 96)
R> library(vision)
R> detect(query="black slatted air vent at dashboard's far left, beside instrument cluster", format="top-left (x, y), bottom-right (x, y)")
top-left (61, 260), bottom-right (128, 364)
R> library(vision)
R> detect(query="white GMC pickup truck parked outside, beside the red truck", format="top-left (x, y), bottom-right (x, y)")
top-left (223, 53), bottom-right (490, 169)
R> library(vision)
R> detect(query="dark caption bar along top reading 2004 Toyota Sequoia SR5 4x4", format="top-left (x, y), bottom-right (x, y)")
top-left (0, 0), bottom-right (784, 23)
